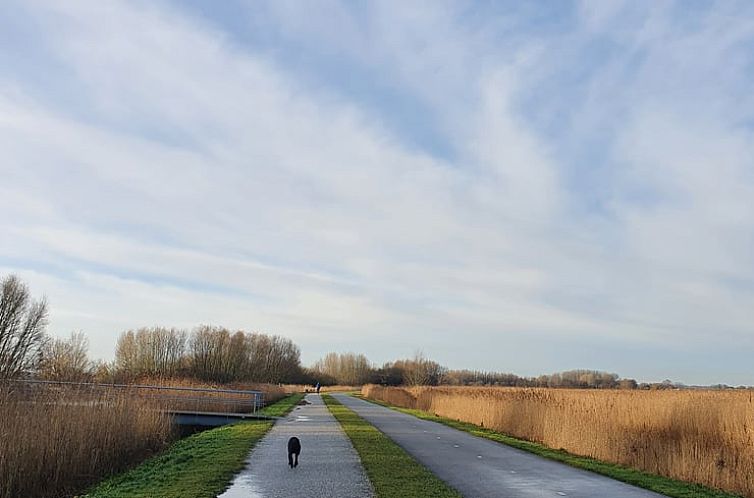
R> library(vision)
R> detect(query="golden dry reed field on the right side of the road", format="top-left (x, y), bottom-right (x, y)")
top-left (362, 385), bottom-right (754, 497)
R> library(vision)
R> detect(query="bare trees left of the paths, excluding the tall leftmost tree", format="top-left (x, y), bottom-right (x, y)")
top-left (15, 326), bottom-right (312, 384)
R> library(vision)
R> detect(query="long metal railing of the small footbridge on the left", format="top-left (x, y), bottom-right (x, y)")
top-left (0, 379), bottom-right (265, 414)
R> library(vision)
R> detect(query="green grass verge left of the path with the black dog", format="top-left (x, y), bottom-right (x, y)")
top-left (85, 394), bottom-right (304, 498)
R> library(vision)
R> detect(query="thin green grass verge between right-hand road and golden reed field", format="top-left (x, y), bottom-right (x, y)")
top-left (353, 394), bottom-right (741, 498)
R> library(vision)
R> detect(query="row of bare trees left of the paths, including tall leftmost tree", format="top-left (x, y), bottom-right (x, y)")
top-left (0, 275), bottom-right (306, 383)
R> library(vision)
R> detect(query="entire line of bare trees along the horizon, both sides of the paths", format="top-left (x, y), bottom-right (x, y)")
top-left (0, 275), bottom-right (656, 389)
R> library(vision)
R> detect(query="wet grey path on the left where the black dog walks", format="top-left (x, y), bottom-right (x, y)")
top-left (220, 394), bottom-right (374, 498)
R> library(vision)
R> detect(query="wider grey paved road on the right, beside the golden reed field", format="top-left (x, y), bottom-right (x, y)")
top-left (335, 394), bottom-right (662, 498)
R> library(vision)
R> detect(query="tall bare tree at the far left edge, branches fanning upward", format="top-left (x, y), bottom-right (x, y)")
top-left (0, 275), bottom-right (47, 378)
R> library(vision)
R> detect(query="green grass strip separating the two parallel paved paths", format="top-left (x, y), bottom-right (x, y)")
top-left (322, 394), bottom-right (461, 498)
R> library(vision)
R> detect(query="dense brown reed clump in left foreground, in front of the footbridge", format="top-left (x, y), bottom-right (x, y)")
top-left (0, 384), bottom-right (173, 498)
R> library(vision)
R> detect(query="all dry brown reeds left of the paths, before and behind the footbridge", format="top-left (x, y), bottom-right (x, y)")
top-left (0, 378), bottom-right (286, 498)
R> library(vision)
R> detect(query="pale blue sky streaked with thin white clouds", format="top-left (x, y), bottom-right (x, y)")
top-left (0, 0), bottom-right (754, 385)
